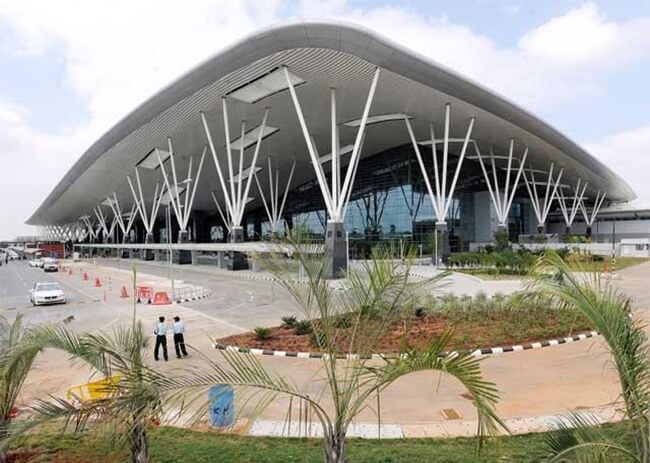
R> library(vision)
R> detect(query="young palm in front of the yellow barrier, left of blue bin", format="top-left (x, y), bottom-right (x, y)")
top-left (3, 321), bottom-right (165, 463)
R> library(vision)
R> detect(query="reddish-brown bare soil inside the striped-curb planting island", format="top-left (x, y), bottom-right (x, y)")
top-left (216, 313), bottom-right (590, 353)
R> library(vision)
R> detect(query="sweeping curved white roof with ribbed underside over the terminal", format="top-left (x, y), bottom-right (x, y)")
top-left (27, 22), bottom-right (636, 225)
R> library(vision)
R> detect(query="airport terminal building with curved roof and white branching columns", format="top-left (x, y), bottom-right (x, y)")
top-left (27, 22), bottom-right (650, 270)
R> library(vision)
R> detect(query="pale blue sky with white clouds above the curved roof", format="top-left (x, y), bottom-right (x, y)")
top-left (0, 0), bottom-right (650, 239)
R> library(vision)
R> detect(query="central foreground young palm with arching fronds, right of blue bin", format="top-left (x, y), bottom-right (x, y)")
top-left (168, 243), bottom-right (505, 463)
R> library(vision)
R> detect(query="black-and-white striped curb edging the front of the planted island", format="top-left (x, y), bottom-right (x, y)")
top-left (212, 331), bottom-right (599, 360)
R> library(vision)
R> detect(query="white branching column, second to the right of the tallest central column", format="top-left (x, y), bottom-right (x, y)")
top-left (475, 139), bottom-right (528, 231)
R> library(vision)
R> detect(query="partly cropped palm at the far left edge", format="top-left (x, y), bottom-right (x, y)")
top-left (0, 314), bottom-right (48, 463)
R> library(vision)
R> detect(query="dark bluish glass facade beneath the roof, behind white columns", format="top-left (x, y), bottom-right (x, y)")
top-left (246, 145), bottom-right (527, 257)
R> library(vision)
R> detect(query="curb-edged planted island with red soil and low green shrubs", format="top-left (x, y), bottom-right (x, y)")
top-left (215, 293), bottom-right (597, 358)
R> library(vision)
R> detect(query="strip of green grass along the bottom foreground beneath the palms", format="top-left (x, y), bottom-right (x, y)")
top-left (11, 424), bottom-right (627, 463)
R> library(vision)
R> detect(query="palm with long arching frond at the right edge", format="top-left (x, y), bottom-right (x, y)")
top-left (529, 251), bottom-right (650, 463)
